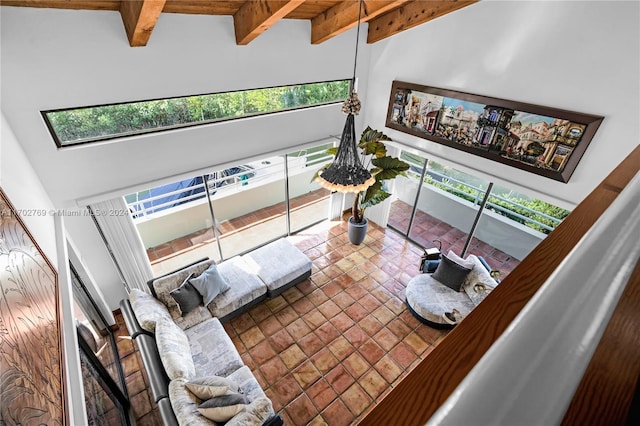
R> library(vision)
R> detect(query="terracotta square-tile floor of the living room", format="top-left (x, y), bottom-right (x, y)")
top-left (116, 222), bottom-right (456, 426)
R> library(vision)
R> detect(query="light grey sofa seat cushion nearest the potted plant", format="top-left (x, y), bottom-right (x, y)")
top-left (242, 238), bottom-right (311, 291)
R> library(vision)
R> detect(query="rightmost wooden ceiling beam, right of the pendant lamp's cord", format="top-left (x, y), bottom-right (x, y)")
top-left (367, 0), bottom-right (477, 43)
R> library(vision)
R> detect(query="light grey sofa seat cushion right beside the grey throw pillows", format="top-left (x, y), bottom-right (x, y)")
top-left (208, 256), bottom-right (267, 318)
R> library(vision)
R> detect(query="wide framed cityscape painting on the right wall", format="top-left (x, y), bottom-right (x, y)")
top-left (386, 81), bottom-right (603, 182)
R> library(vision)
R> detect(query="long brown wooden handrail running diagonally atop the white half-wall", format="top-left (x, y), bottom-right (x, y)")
top-left (359, 146), bottom-right (640, 426)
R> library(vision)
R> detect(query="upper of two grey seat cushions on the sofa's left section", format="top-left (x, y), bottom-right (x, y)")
top-left (185, 318), bottom-right (244, 378)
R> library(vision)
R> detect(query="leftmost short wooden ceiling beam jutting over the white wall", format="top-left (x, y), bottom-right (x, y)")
top-left (120, 0), bottom-right (167, 47)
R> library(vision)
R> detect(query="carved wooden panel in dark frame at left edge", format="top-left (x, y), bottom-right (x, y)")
top-left (0, 188), bottom-right (69, 425)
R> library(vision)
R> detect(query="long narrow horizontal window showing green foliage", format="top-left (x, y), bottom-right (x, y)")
top-left (43, 80), bottom-right (349, 147)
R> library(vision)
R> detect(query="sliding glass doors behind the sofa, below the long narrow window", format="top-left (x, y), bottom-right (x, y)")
top-left (125, 137), bottom-right (337, 276)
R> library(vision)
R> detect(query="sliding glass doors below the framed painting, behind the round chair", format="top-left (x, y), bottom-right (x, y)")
top-left (388, 147), bottom-right (569, 277)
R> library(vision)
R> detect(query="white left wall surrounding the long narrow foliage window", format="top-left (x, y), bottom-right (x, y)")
top-left (1, 7), bottom-right (368, 205)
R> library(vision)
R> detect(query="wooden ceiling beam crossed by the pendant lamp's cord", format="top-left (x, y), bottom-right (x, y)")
top-left (311, 0), bottom-right (409, 44)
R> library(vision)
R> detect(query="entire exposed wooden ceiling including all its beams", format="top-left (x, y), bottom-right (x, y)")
top-left (0, 0), bottom-right (478, 46)
